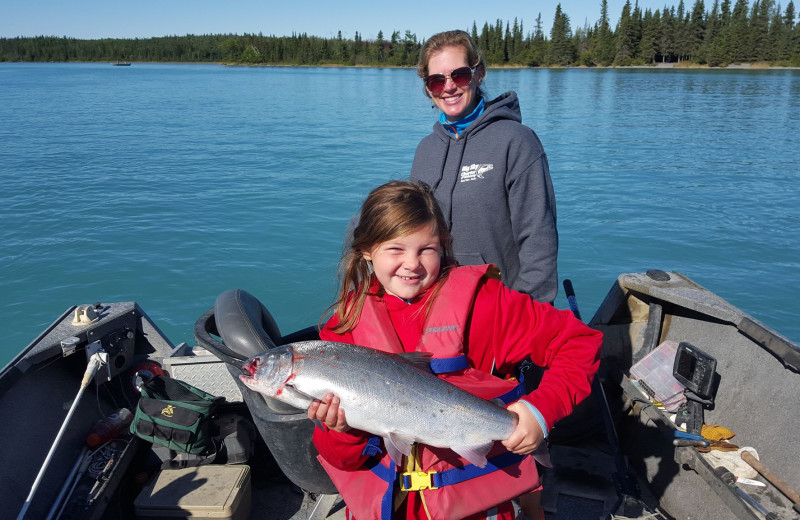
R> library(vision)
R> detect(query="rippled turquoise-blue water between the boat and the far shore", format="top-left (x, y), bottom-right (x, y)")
top-left (0, 63), bottom-right (800, 366)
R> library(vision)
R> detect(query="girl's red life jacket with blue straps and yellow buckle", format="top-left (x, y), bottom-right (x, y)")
top-left (318, 265), bottom-right (540, 520)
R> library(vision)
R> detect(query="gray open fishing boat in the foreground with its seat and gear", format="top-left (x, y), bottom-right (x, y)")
top-left (0, 270), bottom-right (800, 520)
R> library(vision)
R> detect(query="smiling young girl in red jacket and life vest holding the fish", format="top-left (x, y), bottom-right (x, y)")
top-left (308, 181), bottom-right (602, 520)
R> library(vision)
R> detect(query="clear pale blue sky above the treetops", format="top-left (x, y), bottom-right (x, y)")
top-left (0, 0), bottom-right (668, 39)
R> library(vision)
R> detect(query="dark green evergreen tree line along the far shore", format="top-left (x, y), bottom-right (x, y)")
top-left (0, 0), bottom-right (800, 67)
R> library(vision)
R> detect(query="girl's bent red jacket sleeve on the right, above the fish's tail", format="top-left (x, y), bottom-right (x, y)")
top-left (467, 279), bottom-right (603, 429)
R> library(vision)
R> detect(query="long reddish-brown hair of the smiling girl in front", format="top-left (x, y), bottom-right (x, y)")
top-left (331, 181), bottom-right (456, 333)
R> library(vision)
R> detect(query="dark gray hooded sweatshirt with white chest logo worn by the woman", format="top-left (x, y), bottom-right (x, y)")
top-left (411, 92), bottom-right (558, 303)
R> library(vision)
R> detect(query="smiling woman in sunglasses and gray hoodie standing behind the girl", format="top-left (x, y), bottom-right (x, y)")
top-left (411, 31), bottom-right (558, 303)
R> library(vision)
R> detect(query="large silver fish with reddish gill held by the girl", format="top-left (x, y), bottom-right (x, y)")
top-left (239, 341), bottom-right (517, 467)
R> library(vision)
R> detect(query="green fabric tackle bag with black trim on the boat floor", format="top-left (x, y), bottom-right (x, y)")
top-left (131, 376), bottom-right (225, 455)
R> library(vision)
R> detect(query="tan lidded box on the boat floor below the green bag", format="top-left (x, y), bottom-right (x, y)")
top-left (133, 464), bottom-right (252, 520)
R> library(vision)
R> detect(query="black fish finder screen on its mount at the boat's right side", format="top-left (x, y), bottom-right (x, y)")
top-left (672, 341), bottom-right (717, 435)
